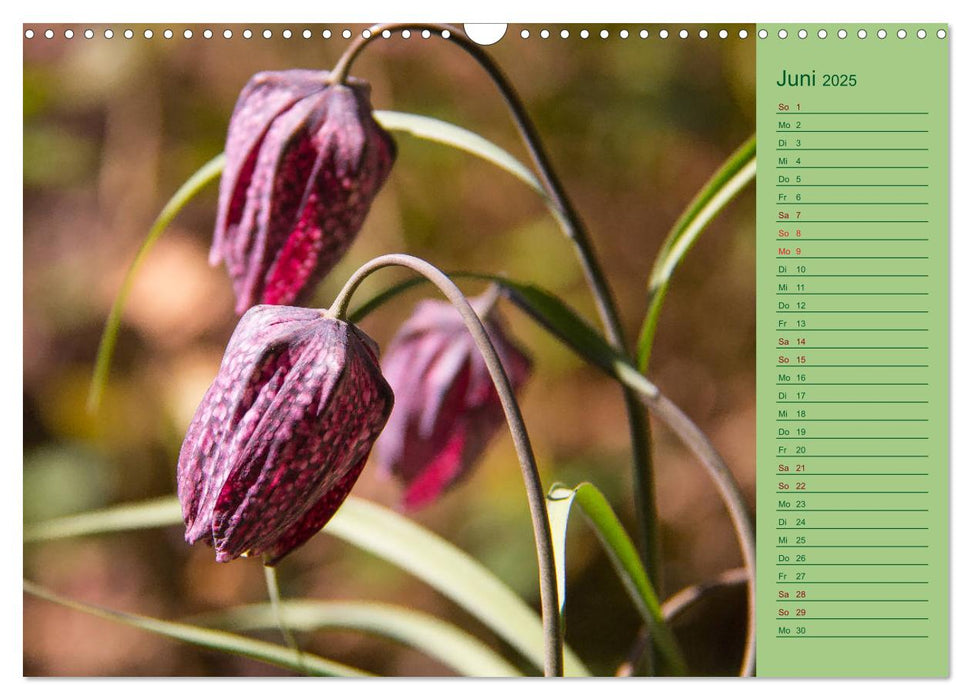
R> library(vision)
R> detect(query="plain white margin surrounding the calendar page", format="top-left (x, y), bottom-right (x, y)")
top-left (0, 0), bottom-right (971, 700)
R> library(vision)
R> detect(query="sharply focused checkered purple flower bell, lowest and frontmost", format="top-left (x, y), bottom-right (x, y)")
top-left (178, 306), bottom-right (394, 564)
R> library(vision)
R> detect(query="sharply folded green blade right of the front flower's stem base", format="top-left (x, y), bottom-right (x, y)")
top-left (547, 483), bottom-right (687, 675)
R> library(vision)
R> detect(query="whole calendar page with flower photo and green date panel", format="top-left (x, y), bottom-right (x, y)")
top-left (21, 19), bottom-right (948, 680)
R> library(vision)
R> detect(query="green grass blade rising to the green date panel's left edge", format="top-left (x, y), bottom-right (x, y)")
top-left (637, 136), bottom-right (755, 372)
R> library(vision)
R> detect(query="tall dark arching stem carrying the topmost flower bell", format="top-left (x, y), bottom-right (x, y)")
top-left (330, 22), bottom-right (661, 590)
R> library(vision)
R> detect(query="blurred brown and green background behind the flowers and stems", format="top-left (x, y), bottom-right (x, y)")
top-left (23, 25), bottom-right (755, 675)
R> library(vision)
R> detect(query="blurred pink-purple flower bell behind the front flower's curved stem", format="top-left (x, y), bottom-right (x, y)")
top-left (375, 293), bottom-right (531, 510)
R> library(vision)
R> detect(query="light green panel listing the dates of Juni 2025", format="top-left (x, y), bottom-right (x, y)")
top-left (757, 24), bottom-right (948, 676)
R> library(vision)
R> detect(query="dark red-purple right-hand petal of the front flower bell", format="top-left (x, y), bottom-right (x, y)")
top-left (212, 319), bottom-right (393, 560)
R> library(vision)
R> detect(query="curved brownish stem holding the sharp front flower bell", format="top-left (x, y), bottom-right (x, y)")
top-left (327, 255), bottom-right (563, 676)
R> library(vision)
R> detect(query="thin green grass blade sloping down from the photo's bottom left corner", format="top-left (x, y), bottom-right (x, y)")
top-left (24, 580), bottom-right (371, 677)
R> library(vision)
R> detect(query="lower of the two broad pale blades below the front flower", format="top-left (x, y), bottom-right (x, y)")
top-left (192, 599), bottom-right (522, 678)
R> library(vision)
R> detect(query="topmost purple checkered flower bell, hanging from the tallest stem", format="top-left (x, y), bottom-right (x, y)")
top-left (209, 70), bottom-right (396, 314)
